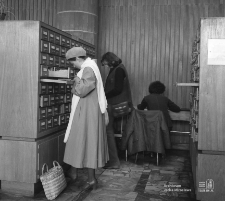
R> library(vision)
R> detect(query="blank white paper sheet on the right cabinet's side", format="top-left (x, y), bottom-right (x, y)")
top-left (208, 39), bottom-right (225, 65)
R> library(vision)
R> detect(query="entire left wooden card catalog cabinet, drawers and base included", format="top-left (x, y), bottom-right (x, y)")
top-left (0, 21), bottom-right (95, 195)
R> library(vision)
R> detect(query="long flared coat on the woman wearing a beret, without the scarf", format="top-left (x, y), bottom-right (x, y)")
top-left (64, 67), bottom-right (109, 169)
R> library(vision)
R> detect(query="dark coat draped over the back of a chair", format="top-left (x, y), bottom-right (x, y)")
top-left (122, 109), bottom-right (171, 155)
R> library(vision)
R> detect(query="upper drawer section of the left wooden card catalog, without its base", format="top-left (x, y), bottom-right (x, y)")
top-left (0, 21), bottom-right (94, 138)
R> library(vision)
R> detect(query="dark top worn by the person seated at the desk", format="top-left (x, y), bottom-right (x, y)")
top-left (137, 94), bottom-right (180, 128)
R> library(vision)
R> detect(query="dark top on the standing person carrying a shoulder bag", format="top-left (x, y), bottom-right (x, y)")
top-left (105, 64), bottom-right (132, 105)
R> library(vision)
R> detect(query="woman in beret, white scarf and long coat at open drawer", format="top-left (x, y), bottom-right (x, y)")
top-left (64, 47), bottom-right (108, 188)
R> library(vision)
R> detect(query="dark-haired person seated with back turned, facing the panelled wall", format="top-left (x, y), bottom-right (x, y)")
top-left (137, 81), bottom-right (181, 131)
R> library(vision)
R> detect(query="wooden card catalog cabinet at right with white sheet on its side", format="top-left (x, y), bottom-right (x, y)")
top-left (190, 18), bottom-right (225, 201)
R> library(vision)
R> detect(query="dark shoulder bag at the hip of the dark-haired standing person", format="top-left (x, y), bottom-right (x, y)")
top-left (112, 101), bottom-right (131, 117)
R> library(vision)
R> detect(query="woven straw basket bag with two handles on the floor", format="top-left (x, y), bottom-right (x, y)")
top-left (40, 161), bottom-right (67, 200)
